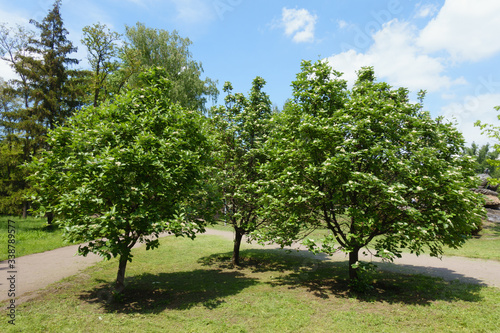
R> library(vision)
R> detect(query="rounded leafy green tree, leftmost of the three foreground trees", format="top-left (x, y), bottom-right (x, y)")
top-left (29, 68), bottom-right (213, 293)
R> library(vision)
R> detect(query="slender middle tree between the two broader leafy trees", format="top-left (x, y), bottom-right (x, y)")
top-left (211, 77), bottom-right (272, 265)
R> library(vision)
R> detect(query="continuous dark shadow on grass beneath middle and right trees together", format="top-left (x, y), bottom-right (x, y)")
top-left (199, 249), bottom-right (485, 305)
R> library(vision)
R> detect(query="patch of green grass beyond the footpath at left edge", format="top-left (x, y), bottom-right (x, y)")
top-left (0, 216), bottom-right (67, 261)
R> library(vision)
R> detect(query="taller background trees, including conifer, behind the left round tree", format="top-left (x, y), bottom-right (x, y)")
top-left (0, 0), bottom-right (218, 216)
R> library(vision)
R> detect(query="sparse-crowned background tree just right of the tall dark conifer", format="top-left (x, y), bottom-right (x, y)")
top-left (82, 23), bottom-right (120, 106)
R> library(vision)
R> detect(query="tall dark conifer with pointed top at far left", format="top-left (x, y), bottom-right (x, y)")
top-left (1, 0), bottom-right (84, 218)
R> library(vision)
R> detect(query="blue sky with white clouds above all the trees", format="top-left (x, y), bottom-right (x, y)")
top-left (0, 0), bottom-right (500, 144)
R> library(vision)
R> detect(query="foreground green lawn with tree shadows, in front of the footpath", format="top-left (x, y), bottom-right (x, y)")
top-left (0, 235), bottom-right (500, 332)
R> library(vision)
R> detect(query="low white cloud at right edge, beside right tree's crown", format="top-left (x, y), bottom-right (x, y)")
top-left (441, 94), bottom-right (500, 145)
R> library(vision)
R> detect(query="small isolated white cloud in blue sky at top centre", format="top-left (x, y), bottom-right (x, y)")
top-left (281, 8), bottom-right (318, 43)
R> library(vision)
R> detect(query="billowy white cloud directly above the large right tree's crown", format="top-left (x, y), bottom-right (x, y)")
top-left (328, 20), bottom-right (465, 92)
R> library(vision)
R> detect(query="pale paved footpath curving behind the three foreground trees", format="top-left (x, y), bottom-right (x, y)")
top-left (0, 229), bottom-right (500, 303)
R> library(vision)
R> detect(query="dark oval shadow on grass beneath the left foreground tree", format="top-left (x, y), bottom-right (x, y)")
top-left (80, 269), bottom-right (258, 313)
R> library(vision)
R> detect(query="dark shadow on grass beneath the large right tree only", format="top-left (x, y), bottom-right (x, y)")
top-left (273, 262), bottom-right (486, 306)
